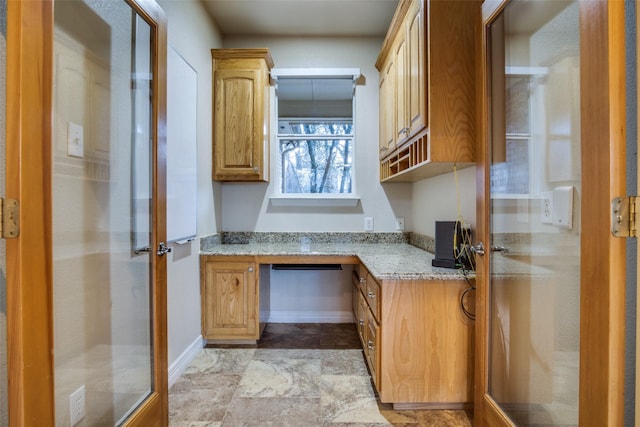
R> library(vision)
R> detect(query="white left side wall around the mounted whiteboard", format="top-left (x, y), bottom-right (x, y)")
top-left (159, 0), bottom-right (221, 372)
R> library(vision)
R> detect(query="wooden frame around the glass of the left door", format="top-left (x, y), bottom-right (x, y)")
top-left (6, 0), bottom-right (168, 427)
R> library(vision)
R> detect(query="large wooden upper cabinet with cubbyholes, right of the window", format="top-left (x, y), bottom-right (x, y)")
top-left (376, 0), bottom-right (481, 182)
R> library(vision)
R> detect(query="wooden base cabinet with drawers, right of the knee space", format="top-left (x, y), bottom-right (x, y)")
top-left (353, 266), bottom-right (473, 409)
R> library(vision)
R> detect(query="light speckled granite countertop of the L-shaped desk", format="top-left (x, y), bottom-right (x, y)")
top-left (200, 242), bottom-right (473, 280)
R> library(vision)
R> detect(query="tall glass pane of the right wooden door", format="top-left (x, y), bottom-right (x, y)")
top-left (489, 0), bottom-right (581, 426)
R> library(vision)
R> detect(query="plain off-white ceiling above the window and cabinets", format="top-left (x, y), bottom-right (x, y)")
top-left (201, 0), bottom-right (398, 37)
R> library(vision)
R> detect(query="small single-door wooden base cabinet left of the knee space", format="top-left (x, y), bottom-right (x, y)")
top-left (200, 256), bottom-right (269, 342)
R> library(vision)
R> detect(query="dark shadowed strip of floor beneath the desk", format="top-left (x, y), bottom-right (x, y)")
top-left (207, 323), bottom-right (362, 350)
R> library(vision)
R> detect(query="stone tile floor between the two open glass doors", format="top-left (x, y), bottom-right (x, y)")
top-left (169, 324), bottom-right (472, 427)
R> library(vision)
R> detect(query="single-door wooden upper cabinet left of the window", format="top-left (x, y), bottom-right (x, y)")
top-left (211, 49), bottom-right (273, 181)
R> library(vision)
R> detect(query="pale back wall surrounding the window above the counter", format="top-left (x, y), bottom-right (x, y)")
top-left (222, 37), bottom-right (412, 232)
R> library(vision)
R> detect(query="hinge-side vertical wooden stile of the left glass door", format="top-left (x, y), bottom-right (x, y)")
top-left (6, 0), bottom-right (55, 427)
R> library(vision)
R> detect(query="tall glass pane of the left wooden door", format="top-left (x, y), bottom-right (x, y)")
top-left (52, 0), bottom-right (153, 426)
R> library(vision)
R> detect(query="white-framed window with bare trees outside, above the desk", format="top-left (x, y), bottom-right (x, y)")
top-left (272, 69), bottom-right (360, 199)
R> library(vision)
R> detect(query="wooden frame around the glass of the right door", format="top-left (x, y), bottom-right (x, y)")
top-left (474, 0), bottom-right (626, 426)
